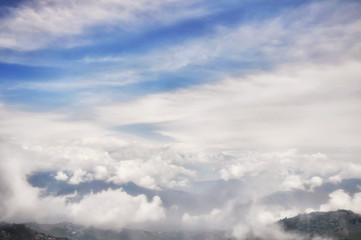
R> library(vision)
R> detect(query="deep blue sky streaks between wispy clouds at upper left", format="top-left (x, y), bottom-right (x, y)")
top-left (0, 1), bottom-right (318, 109)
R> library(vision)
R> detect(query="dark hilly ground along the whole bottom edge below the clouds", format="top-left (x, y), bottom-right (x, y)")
top-left (0, 210), bottom-right (361, 240)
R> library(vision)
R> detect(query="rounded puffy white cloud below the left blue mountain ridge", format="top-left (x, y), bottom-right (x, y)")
top-left (67, 189), bottom-right (165, 229)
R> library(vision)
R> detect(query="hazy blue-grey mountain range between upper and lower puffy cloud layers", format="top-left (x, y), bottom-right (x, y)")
top-left (27, 172), bottom-right (361, 218)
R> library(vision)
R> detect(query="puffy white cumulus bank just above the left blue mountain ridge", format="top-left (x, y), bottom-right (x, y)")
top-left (41, 143), bottom-right (196, 190)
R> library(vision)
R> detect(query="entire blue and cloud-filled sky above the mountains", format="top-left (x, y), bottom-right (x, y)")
top-left (0, 0), bottom-right (361, 235)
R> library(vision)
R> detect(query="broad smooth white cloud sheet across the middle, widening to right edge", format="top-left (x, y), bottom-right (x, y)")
top-left (96, 62), bottom-right (361, 154)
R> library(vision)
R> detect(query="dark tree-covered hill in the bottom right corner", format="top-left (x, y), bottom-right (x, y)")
top-left (279, 210), bottom-right (361, 240)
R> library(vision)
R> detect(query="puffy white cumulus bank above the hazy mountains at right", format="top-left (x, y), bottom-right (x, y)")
top-left (219, 149), bottom-right (340, 198)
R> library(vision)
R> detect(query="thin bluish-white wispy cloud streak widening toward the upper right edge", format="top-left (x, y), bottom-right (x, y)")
top-left (83, 1), bottom-right (361, 74)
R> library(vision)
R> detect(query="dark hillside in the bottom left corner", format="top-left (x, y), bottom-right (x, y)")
top-left (0, 223), bottom-right (68, 240)
